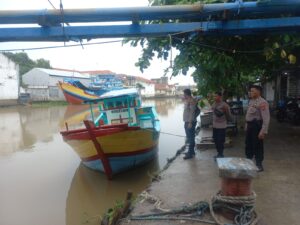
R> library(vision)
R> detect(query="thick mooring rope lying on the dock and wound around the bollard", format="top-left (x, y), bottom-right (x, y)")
top-left (134, 191), bottom-right (258, 225)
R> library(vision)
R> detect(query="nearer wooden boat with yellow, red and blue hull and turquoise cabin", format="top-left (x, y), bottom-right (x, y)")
top-left (61, 89), bottom-right (160, 179)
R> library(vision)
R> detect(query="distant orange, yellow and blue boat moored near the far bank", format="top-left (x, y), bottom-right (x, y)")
top-left (59, 75), bottom-right (123, 104)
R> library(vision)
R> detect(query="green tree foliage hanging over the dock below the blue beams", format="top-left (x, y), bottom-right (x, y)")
top-left (127, 0), bottom-right (300, 96)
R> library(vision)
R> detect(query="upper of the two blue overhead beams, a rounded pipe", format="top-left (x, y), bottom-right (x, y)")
top-left (0, 0), bottom-right (300, 26)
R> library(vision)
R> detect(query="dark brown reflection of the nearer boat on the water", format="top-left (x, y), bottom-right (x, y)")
top-left (66, 160), bottom-right (158, 225)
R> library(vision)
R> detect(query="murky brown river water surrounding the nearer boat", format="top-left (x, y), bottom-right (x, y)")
top-left (0, 99), bottom-right (184, 225)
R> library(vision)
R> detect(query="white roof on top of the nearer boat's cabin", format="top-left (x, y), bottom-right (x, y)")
top-left (85, 88), bottom-right (138, 103)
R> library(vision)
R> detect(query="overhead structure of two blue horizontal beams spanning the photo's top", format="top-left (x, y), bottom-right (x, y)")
top-left (0, 0), bottom-right (300, 42)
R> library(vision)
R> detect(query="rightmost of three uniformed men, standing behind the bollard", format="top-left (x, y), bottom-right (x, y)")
top-left (245, 85), bottom-right (270, 172)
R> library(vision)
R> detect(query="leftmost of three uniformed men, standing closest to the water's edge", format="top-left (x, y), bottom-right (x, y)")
top-left (183, 89), bottom-right (197, 159)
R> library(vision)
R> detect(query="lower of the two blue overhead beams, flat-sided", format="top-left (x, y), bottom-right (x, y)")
top-left (0, 17), bottom-right (300, 42)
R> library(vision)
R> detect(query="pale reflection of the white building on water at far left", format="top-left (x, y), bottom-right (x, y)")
top-left (0, 107), bottom-right (64, 156)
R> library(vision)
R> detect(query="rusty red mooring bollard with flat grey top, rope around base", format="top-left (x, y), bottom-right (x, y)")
top-left (211, 158), bottom-right (257, 224)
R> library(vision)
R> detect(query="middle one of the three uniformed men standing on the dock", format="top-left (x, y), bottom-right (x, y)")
top-left (212, 92), bottom-right (232, 159)
